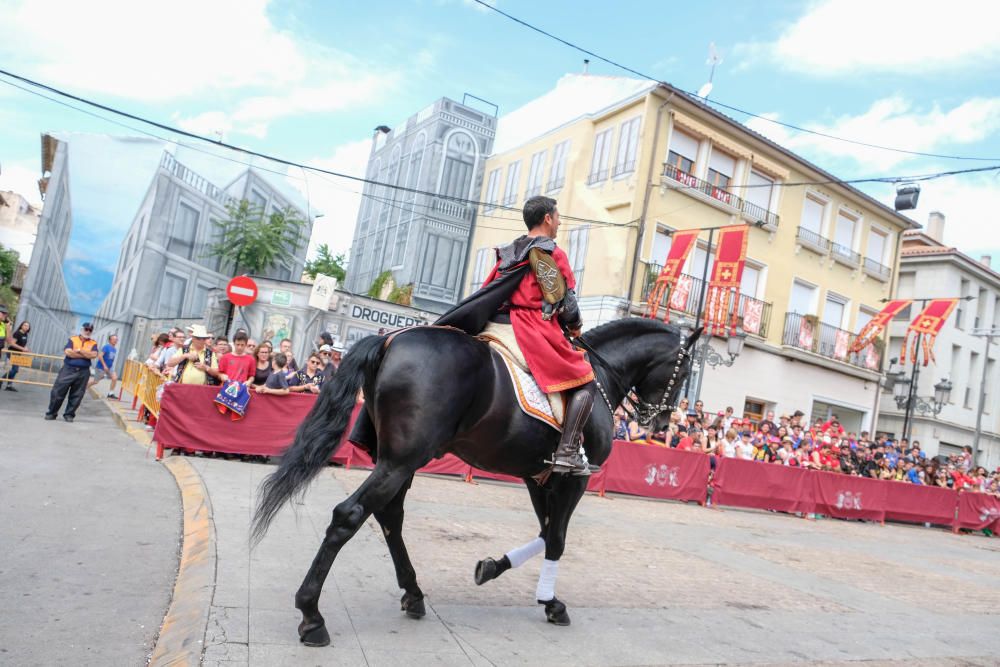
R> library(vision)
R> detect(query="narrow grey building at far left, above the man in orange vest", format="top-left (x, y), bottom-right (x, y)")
top-left (17, 134), bottom-right (78, 354)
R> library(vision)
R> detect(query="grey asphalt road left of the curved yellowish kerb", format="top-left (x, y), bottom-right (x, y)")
top-left (0, 385), bottom-right (181, 667)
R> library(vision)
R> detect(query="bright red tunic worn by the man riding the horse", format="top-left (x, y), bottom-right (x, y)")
top-left (483, 247), bottom-right (594, 394)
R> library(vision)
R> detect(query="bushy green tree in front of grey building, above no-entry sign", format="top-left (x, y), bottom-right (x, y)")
top-left (208, 199), bottom-right (306, 274)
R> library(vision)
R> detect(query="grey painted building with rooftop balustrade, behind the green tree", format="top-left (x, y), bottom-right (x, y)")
top-left (95, 151), bottom-right (313, 366)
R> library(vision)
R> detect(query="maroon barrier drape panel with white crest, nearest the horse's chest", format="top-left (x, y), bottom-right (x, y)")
top-left (604, 440), bottom-right (709, 503)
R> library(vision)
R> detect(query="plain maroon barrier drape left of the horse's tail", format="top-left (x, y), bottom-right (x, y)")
top-left (153, 384), bottom-right (316, 456)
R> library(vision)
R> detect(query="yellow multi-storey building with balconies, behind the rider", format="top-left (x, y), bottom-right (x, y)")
top-left (466, 74), bottom-right (916, 431)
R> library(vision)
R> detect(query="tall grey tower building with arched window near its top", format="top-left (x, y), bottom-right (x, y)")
top-left (345, 98), bottom-right (496, 312)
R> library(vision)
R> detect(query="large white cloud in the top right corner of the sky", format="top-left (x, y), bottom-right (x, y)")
top-left (734, 0), bottom-right (1000, 76)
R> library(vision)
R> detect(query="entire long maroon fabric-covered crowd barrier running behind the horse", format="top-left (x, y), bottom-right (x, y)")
top-left (143, 386), bottom-right (1000, 533)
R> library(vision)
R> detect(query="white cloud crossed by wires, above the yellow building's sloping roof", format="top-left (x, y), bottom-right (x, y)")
top-left (746, 96), bottom-right (1000, 171)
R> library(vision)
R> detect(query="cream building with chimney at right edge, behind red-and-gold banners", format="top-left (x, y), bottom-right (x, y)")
top-left (878, 213), bottom-right (1000, 469)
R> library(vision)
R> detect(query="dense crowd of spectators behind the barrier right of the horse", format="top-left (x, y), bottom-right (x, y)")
top-left (615, 399), bottom-right (1000, 496)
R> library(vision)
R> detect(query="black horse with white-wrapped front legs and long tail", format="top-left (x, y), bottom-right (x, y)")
top-left (252, 318), bottom-right (701, 646)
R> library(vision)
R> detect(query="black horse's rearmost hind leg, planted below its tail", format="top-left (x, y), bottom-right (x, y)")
top-left (295, 461), bottom-right (413, 646)
